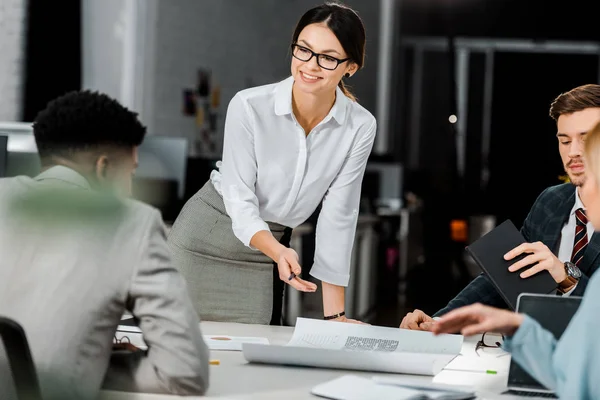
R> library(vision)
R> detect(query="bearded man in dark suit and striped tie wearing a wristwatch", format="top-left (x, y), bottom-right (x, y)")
top-left (400, 85), bottom-right (600, 330)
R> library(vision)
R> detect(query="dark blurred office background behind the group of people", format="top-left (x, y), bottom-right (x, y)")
top-left (0, 0), bottom-right (600, 326)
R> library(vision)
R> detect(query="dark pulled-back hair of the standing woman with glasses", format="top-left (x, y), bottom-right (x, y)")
top-left (292, 2), bottom-right (366, 101)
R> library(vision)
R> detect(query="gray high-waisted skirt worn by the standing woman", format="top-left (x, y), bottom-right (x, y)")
top-left (168, 181), bottom-right (286, 324)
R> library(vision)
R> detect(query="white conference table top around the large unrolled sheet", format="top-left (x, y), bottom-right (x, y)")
top-left (100, 322), bottom-right (548, 400)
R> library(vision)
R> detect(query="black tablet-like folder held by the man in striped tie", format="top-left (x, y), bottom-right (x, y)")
top-left (466, 220), bottom-right (556, 310)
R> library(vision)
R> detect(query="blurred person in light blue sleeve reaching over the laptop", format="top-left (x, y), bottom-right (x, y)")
top-left (432, 120), bottom-right (600, 399)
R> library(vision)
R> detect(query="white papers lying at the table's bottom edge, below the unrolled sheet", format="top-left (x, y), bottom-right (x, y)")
top-left (311, 375), bottom-right (475, 400)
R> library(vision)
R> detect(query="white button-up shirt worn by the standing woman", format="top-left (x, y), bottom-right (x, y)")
top-left (211, 77), bottom-right (376, 286)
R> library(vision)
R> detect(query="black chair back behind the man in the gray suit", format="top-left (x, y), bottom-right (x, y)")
top-left (0, 317), bottom-right (42, 400)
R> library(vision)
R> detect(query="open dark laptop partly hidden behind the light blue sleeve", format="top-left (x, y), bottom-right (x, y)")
top-left (508, 294), bottom-right (581, 390)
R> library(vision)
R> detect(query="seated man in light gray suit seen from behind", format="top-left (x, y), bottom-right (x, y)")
top-left (0, 91), bottom-right (208, 400)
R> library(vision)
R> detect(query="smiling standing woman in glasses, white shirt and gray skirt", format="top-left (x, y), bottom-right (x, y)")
top-left (169, 3), bottom-right (376, 324)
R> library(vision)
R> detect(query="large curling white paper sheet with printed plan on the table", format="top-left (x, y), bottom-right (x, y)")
top-left (242, 318), bottom-right (463, 376)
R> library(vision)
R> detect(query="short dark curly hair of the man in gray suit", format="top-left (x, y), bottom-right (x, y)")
top-left (33, 90), bottom-right (146, 160)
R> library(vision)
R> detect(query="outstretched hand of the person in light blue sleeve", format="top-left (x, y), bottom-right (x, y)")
top-left (432, 304), bottom-right (523, 336)
